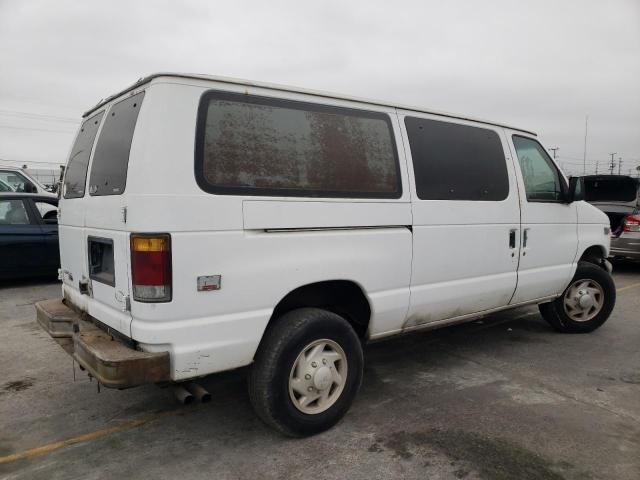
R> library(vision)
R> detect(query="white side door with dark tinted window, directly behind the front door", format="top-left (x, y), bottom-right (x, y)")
top-left (402, 113), bottom-right (520, 328)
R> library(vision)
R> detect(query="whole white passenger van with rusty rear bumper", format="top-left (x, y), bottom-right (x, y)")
top-left (37, 73), bottom-right (615, 435)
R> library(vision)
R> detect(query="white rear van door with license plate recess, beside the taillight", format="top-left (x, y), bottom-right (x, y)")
top-left (83, 92), bottom-right (144, 336)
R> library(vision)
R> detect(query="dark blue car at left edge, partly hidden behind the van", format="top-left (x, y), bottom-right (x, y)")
top-left (0, 192), bottom-right (60, 280)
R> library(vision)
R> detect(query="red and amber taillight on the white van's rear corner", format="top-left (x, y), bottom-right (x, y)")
top-left (131, 234), bottom-right (172, 302)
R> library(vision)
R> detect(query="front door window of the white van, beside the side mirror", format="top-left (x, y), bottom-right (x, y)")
top-left (513, 135), bottom-right (564, 202)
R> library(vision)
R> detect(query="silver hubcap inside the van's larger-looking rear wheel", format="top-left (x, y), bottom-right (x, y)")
top-left (289, 338), bottom-right (347, 414)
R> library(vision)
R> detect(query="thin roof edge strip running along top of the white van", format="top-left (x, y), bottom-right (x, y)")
top-left (82, 72), bottom-right (537, 136)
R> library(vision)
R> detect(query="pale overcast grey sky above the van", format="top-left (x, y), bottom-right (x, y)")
top-left (0, 0), bottom-right (640, 173)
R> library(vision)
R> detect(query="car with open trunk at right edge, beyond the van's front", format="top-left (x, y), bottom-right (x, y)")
top-left (583, 175), bottom-right (640, 259)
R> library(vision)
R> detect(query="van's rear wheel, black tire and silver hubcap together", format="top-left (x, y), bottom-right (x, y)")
top-left (248, 308), bottom-right (364, 437)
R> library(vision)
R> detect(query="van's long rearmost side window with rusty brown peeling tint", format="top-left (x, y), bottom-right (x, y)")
top-left (195, 91), bottom-right (402, 198)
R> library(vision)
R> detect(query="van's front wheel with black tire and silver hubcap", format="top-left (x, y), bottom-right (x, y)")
top-left (539, 262), bottom-right (616, 333)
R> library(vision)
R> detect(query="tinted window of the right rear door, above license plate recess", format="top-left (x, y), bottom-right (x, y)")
top-left (89, 92), bottom-right (144, 195)
